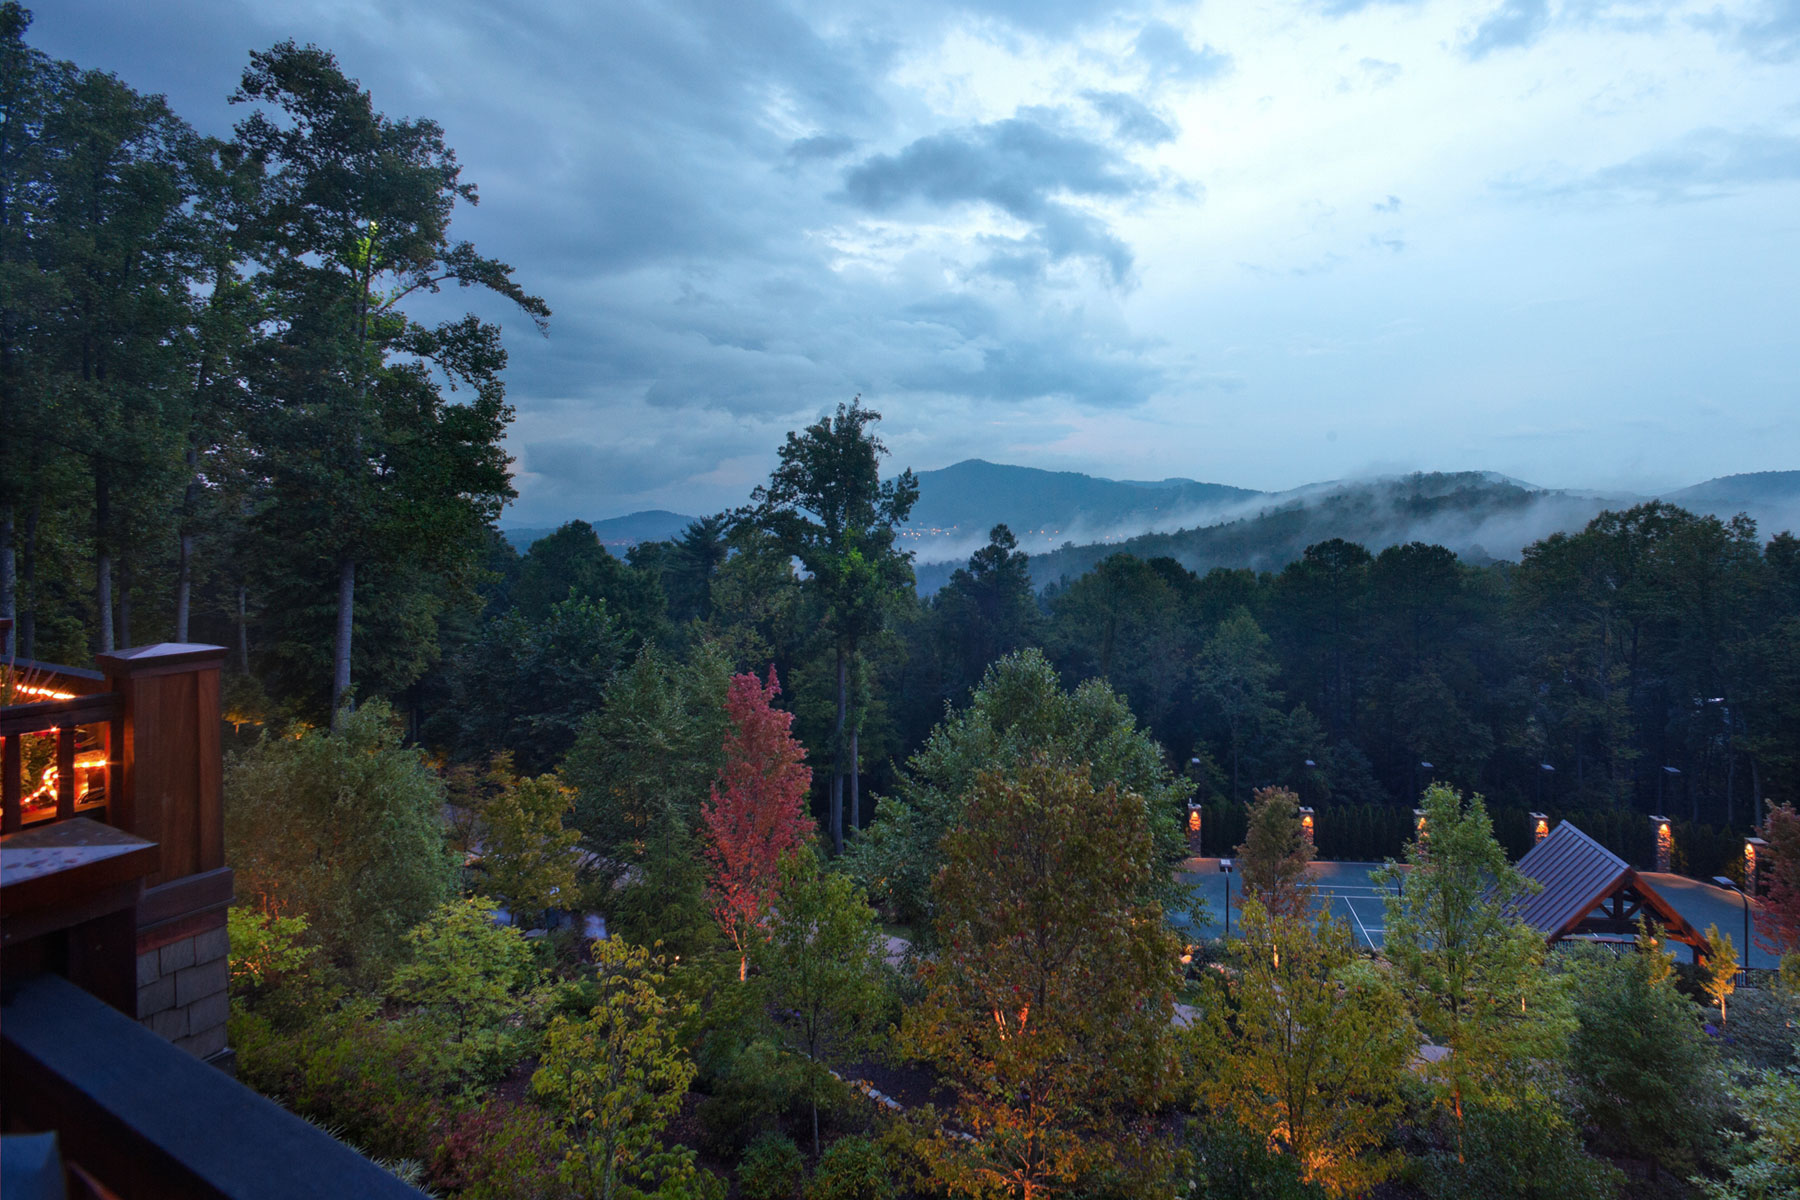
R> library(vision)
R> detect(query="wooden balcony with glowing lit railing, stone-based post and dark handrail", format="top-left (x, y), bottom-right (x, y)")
top-left (0, 621), bottom-right (421, 1200)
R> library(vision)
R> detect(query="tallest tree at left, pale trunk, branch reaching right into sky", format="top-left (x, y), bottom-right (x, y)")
top-left (232, 41), bottom-right (549, 720)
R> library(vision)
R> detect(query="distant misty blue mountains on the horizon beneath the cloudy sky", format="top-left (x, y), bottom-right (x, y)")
top-left (504, 459), bottom-right (1800, 594)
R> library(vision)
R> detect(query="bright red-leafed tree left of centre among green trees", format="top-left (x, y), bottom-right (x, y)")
top-left (700, 667), bottom-right (814, 979)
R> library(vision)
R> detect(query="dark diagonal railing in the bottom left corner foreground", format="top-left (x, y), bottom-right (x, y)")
top-left (0, 975), bottom-right (423, 1200)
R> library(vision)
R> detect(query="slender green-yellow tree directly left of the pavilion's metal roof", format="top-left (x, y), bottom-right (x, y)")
top-left (1375, 784), bottom-right (1568, 1153)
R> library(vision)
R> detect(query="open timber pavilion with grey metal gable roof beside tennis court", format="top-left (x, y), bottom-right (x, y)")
top-left (1517, 820), bottom-right (1706, 963)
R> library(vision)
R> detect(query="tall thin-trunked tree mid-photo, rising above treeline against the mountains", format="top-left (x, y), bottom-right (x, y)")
top-left (742, 399), bottom-right (918, 853)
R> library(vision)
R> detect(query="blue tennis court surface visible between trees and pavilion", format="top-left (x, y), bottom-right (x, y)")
top-left (1172, 858), bottom-right (1780, 968)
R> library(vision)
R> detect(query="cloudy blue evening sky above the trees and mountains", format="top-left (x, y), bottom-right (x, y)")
top-left (31, 0), bottom-right (1800, 524)
